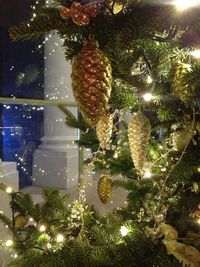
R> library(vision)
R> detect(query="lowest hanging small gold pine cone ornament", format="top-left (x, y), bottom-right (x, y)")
top-left (98, 173), bottom-right (112, 204)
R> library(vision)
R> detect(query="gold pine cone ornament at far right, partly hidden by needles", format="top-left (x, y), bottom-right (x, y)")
top-left (172, 63), bottom-right (194, 103)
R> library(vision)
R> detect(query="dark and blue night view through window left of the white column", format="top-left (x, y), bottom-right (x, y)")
top-left (0, 0), bottom-right (44, 187)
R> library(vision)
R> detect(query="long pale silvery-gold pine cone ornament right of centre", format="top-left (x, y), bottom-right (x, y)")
top-left (128, 111), bottom-right (151, 171)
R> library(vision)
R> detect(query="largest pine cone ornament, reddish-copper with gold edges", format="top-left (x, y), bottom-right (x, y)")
top-left (72, 40), bottom-right (112, 126)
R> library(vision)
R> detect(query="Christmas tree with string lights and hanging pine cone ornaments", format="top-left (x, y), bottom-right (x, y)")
top-left (0, 0), bottom-right (200, 267)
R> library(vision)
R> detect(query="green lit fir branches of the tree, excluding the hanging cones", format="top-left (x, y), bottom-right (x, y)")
top-left (4, 0), bottom-right (200, 267)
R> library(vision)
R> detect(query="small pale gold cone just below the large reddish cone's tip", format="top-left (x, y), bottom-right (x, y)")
top-left (96, 113), bottom-right (113, 149)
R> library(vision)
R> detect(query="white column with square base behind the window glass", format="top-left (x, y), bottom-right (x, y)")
top-left (33, 34), bottom-right (79, 188)
